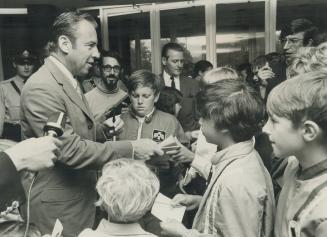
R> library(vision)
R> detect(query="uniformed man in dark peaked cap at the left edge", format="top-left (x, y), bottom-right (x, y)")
top-left (0, 49), bottom-right (36, 141)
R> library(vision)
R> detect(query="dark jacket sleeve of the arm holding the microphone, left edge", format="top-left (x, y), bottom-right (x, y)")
top-left (0, 152), bottom-right (25, 212)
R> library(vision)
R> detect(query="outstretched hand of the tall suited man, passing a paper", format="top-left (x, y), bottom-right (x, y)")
top-left (131, 139), bottom-right (164, 160)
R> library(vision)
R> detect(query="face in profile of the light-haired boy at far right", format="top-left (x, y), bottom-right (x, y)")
top-left (263, 115), bottom-right (303, 158)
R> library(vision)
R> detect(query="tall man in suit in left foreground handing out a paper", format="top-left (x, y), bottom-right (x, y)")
top-left (21, 12), bottom-right (163, 237)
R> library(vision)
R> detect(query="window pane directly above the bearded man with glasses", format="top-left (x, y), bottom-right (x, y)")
top-left (108, 12), bottom-right (152, 74)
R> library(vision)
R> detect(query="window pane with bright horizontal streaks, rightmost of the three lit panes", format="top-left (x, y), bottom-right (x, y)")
top-left (216, 2), bottom-right (265, 66)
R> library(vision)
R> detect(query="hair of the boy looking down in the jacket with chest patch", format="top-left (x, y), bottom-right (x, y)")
top-left (126, 70), bottom-right (163, 95)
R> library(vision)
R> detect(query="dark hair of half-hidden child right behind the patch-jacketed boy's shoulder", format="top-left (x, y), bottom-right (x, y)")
top-left (156, 86), bottom-right (183, 115)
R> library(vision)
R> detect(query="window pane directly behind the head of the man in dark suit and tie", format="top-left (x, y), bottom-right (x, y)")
top-left (160, 6), bottom-right (206, 75)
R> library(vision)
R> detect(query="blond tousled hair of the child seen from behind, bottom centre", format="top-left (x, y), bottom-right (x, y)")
top-left (96, 158), bottom-right (160, 223)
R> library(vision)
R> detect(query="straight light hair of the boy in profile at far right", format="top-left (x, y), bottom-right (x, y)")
top-left (267, 71), bottom-right (327, 136)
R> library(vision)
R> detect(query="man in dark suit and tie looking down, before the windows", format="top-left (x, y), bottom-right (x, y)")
top-left (161, 43), bottom-right (200, 134)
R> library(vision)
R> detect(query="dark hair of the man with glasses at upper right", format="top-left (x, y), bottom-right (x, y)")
top-left (280, 18), bottom-right (318, 46)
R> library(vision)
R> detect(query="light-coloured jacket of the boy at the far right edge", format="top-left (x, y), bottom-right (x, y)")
top-left (275, 157), bottom-right (327, 237)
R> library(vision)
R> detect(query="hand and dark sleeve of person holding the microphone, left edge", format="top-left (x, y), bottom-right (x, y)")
top-left (0, 137), bottom-right (62, 219)
